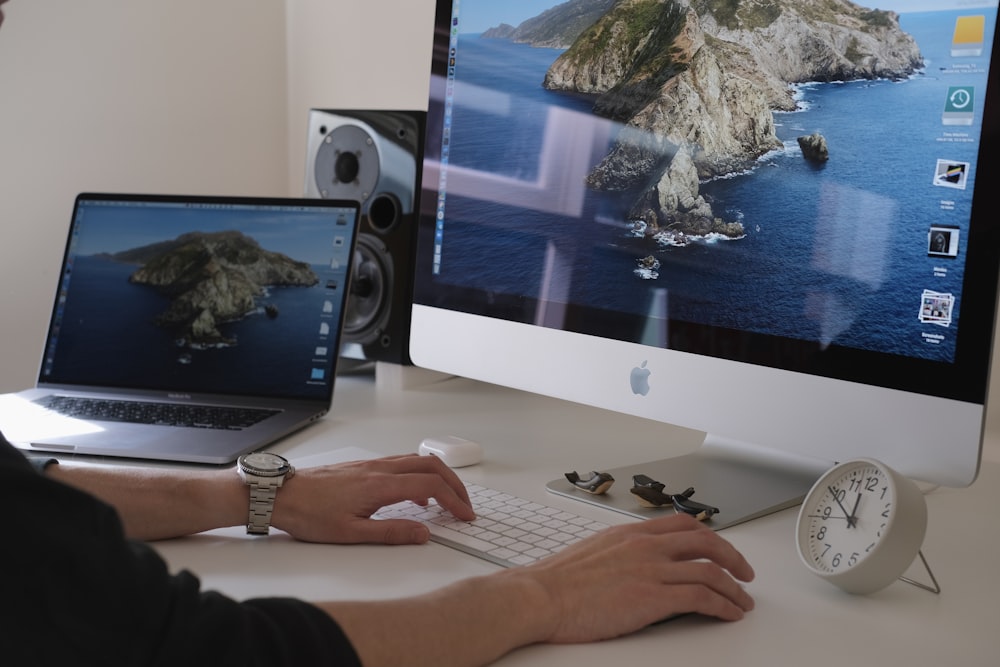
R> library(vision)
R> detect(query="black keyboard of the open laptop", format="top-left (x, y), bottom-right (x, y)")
top-left (36, 395), bottom-right (278, 430)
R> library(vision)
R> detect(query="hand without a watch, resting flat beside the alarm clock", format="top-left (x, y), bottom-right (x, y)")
top-left (510, 514), bottom-right (754, 643)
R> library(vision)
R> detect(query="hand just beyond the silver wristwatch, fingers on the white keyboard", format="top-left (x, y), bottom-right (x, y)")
top-left (272, 454), bottom-right (475, 544)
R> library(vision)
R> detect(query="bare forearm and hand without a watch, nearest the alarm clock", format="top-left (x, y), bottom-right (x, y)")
top-left (319, 514), bottom-right (753, 665)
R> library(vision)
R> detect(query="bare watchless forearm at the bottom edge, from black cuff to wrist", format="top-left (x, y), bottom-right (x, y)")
top-left (318, 570), bottom-right (552, 667)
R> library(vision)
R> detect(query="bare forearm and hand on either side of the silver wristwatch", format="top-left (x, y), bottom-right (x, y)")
top-left (46, 455), bottom-right (475, 544)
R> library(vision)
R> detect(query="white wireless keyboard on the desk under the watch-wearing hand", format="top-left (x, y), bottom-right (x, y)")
top-left (372, 484), bottom-right (608, 567)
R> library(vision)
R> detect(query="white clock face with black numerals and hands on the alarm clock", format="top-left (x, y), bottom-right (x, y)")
top-left (799, 461), bottom-right (896, 574)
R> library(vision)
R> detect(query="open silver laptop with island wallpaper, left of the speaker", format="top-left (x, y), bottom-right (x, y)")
top-left (0, 193), bottom-right (359, 464)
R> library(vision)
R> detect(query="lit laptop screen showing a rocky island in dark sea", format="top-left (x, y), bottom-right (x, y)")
top-left (41, 203), bottom-right (354, 397)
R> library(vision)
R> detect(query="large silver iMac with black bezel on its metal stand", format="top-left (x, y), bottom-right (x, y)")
top-left (410, 0), bottom-right (1000, 527)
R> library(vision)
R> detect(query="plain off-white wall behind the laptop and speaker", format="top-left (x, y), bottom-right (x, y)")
top-left (0, 0), bottom-right (1000, 460)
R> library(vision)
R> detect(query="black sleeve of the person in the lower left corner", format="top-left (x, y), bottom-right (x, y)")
top-left (0, 436), bottom-right (360, 667)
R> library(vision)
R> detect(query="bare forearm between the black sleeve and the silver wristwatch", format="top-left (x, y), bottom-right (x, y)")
top-left (46, 463), bottom-right (248, 540)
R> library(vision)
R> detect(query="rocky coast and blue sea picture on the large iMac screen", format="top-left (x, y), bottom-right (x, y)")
top-left (425, 0), bottom-right (997, 361)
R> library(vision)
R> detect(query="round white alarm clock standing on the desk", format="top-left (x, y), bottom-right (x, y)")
top-left (796, 458), bottom-right (933, 594)
